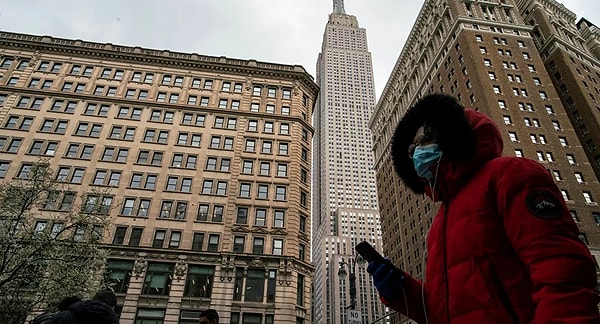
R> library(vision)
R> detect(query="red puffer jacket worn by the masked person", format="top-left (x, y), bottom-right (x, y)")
top-left (383, 109), bottom-right (600, 324)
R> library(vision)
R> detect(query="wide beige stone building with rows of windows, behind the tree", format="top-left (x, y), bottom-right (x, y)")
top-left (0, 32), bottom-right (318, 324)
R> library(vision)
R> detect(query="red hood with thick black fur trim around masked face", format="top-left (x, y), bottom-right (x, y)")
top-left (392, 94), bottom-right (503, 200)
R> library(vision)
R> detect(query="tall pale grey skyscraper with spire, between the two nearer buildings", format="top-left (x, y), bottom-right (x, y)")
top-left (312, 0), bottom-right (384, 324)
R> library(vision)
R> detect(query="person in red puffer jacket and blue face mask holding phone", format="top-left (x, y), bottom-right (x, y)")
top-left (367, 94), bottom-right (600, 324)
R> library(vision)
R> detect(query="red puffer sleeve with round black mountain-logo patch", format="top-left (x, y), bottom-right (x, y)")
top-left (496, 158), bottom-right (600, 323)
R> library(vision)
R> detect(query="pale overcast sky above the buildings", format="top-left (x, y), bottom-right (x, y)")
top-left (0, 0), bottom-right (600, 97)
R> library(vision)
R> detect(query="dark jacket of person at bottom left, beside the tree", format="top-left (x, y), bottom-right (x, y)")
top-left (50, 300), bottom-right (119, 324)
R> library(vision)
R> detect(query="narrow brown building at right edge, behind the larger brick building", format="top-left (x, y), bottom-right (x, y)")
top-left (517, 1), bottom-right (600, 179)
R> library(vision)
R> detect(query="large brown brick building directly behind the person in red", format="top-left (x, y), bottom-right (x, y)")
top-left (370, 0), bottom-right (600, 322)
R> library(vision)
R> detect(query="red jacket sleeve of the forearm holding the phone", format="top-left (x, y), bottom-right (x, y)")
top-left (380, 272), bottom-right (426, 323)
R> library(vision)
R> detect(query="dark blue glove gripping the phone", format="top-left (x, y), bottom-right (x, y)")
top-left (367, 258), bottom-right (405, 300)
